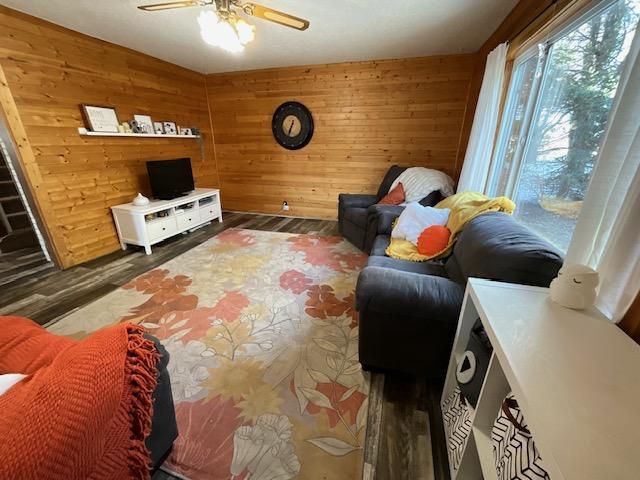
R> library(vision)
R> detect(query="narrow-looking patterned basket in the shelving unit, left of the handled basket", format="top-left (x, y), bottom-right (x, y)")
top-left (442, 387), bottom-right (471, 470)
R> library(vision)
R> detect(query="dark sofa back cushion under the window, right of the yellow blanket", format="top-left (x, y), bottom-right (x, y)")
top-left (445, 213), bottom-right (563, 287)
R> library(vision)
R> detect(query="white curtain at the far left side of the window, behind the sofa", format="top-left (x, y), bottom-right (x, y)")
top-left (458, 43), bottom-right (508, 193)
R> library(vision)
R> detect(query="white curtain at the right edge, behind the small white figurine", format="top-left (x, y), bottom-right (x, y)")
top-left (567, 26), bottom-right (640, 322)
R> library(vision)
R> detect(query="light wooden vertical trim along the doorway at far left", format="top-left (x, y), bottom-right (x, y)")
top-left (0, 61), bottom-right (67, 268)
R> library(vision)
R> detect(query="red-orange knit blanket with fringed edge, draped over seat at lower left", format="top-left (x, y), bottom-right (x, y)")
top-left (0, 316), bottom-right (158, 480)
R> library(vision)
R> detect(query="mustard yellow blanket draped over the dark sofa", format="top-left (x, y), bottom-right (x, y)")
top-left (386, 192), bottom-right (516, 262)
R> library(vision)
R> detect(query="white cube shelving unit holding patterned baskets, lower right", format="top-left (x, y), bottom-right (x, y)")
top-left (442, 279), bottom-right (640, 480)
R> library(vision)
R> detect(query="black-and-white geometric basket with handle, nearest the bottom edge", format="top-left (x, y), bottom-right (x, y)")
top-left (491, 394), bottom-right (549, 480)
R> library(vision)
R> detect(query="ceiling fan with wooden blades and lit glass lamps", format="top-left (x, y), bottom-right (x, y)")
top-left (138, 0), bottom-right (309, 52)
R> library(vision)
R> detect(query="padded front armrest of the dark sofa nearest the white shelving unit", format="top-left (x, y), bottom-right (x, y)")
top-left (356, 267), bottom-right (464, 323)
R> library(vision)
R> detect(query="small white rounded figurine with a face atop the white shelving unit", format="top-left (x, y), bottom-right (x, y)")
top-left (549, 264), bottom-right (600, 310)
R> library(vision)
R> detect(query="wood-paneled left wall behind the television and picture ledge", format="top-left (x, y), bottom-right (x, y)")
top-left (0, 7), bottom-right (218, 267)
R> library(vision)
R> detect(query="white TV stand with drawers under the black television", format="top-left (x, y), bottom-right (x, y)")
top-left (111, 188), bottom-right (222, 255)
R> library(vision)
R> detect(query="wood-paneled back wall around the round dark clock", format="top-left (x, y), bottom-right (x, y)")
top-left (207, 55), bottom-right (476, 218)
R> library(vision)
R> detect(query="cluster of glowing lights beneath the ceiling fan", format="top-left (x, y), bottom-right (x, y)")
top-left (198, 11), bottom-right (254, 53)
